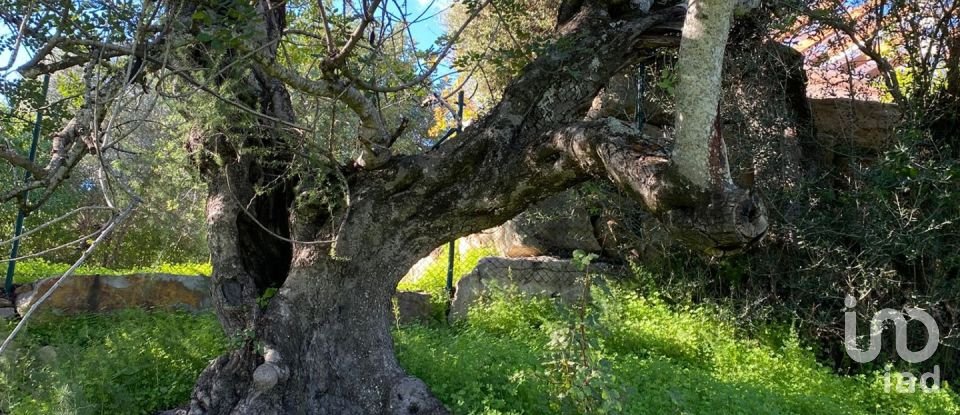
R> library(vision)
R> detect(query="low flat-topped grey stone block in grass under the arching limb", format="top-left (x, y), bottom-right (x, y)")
top-left (449, 257), bottom-right (623, 321)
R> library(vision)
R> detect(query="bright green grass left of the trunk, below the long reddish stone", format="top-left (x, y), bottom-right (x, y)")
top-left (0, 310), bottom-right (226, 415)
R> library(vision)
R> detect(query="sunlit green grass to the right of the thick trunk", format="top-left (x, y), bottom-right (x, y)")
top-left (395, 289), bottom-right (960, 414)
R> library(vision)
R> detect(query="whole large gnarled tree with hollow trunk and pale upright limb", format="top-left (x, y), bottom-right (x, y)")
top-left (0, 0), bottom-right (767, 414)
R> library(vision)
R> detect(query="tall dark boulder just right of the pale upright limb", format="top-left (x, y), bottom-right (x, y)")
top-left (720, 39), bottom-right (823, 192)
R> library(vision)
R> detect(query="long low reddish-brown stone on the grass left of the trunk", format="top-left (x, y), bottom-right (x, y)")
top-left (17, 274), bottom-right (211, 315)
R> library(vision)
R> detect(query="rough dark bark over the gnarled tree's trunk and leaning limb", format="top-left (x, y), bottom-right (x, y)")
top-left (174, 1), bottom-right (766, 414)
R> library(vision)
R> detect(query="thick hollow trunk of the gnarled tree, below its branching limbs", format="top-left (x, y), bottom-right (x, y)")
top-left (189, 132), bottom-right (445, 414)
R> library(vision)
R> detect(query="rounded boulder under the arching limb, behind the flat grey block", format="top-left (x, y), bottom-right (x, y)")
top-left (494, 191), bottom-right (601, 258)
